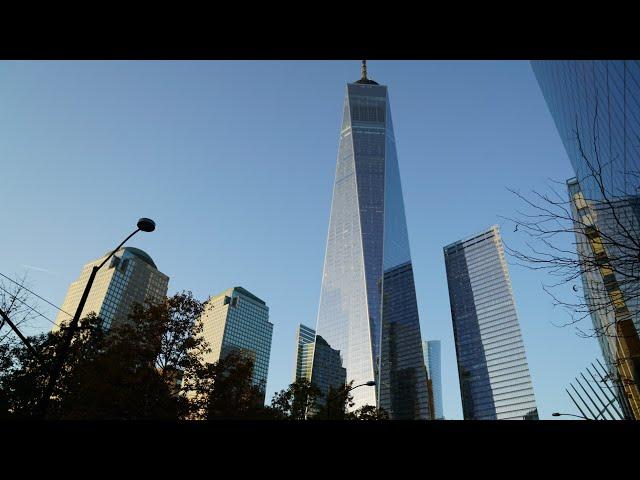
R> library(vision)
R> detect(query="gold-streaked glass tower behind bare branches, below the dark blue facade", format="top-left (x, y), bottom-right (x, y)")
top-left (567, 178), bottom-right (640, 419)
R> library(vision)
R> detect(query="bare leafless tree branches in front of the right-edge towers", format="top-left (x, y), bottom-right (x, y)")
top-left (505, 110), bottom-right (640, 418)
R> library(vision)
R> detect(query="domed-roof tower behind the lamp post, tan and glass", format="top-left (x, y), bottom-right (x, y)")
top-left (53, 247), bottom-right (169, 330)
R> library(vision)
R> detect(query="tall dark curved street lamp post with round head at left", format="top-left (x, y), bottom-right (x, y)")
top-left (38, 218), bottom-right (156, 418)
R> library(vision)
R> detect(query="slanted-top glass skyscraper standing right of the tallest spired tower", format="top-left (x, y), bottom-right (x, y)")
top-left (444, 225), bottom-right (538, 420)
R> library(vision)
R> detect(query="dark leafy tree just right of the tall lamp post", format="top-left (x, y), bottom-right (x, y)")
top-left (57, 292), bottom-right (208, 419)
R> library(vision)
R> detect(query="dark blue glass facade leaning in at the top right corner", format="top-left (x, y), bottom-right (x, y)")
top-left (531, 60), bottom-right (640, 200)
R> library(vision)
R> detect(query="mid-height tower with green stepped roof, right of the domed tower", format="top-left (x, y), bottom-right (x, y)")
top-left (201, 287), bottom-right (273, 400)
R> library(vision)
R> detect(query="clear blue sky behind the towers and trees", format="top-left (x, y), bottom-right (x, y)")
top-left (0, 60), bottom-right (600, 419)
